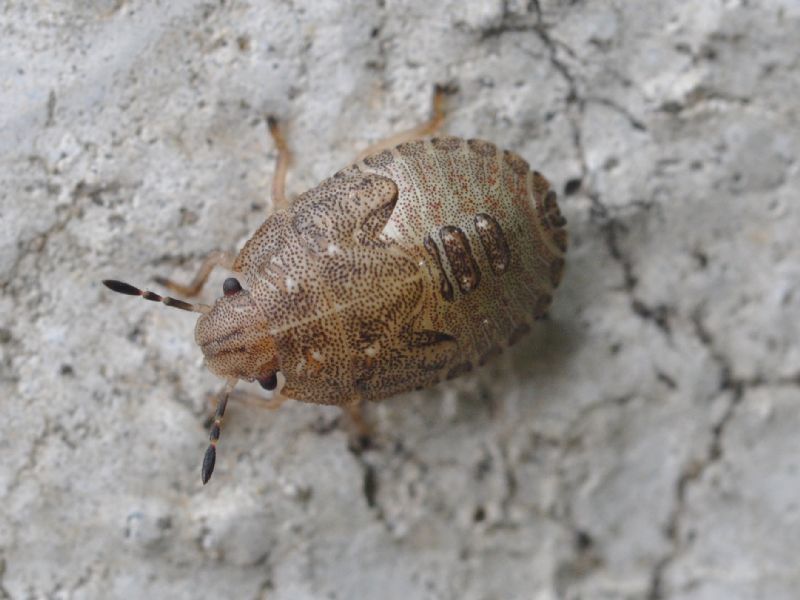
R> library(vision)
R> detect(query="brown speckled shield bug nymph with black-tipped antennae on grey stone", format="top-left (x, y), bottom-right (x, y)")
top-left (103, 86), bottom-right (567, 484)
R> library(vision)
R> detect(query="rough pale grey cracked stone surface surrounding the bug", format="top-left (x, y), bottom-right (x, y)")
top-left (0, 0), bottom-right (800, 600)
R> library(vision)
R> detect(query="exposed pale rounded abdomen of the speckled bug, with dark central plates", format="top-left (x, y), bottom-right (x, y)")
top-left (356, 137), bottom-right (567, 378)
